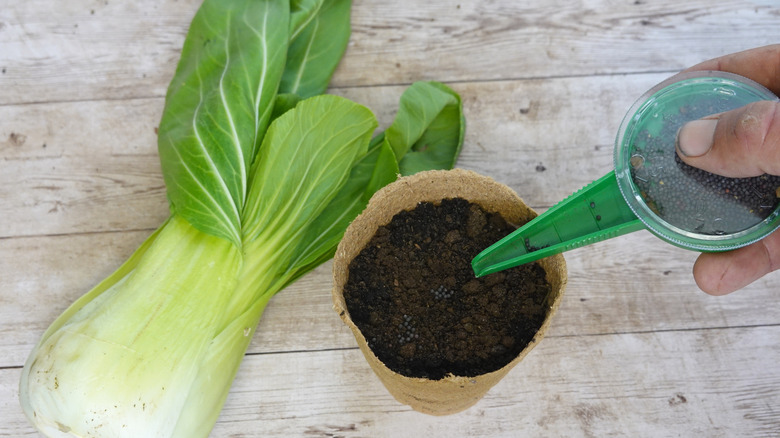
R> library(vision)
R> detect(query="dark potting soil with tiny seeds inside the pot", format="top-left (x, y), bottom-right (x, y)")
top-left (344, 199), bottom-right (551, 380)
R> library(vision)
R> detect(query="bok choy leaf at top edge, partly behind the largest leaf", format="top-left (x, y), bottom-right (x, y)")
top-left (279, 0), bottom-right (352, 98)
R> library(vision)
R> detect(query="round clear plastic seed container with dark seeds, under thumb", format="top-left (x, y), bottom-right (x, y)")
top-left (615, 71), bottom-right (780, 251)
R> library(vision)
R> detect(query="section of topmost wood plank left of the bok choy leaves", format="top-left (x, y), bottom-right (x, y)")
top-left (0, 0), bottom-right (201, 104)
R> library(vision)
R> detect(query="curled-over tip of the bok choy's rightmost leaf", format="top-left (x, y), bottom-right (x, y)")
top-left (385, 82), bottom-right (466, 175)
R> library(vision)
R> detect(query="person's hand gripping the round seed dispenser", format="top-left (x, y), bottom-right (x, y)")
top-left (677, 44), bottom-right (780, 295)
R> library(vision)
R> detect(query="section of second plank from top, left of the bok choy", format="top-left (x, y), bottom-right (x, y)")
top-left (0, 99), bottom-right (168, 238)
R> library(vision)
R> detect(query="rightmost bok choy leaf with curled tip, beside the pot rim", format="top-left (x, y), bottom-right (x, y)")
top-left (278, 82), bottom-right (465, 284)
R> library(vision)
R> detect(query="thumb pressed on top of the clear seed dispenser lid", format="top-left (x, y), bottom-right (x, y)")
top-left (677, 101), bottom-right (780, 178)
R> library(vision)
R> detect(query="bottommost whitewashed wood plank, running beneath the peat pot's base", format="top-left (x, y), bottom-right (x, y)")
top-left (0, 326), bottom-right (780, 438)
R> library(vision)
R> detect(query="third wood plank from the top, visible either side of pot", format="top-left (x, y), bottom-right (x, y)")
top-left (0, 226), bottom-right (780, 367)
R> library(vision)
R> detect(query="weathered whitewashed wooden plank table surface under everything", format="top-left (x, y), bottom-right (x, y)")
top-left (0, 0), bottom-right (780, 437)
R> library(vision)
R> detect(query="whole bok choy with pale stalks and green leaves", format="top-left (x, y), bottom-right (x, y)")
top-left (20, 0), bottom-right (464, 438)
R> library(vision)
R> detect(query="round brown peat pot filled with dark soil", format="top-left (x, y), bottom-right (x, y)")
top-left (333, 169), bottom-right (567, 415)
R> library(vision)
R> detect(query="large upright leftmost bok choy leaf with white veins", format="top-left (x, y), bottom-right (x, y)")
top-left (159, 0), bottom-right (290, 245)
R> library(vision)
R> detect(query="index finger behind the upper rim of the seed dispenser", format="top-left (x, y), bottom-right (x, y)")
top-left (683, 44), bottom-right (780, 95)
